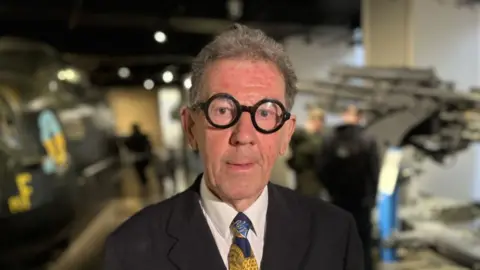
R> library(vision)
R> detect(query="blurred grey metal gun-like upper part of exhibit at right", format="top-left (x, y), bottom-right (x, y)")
top-left (298, 67), bottom-right (480, 162)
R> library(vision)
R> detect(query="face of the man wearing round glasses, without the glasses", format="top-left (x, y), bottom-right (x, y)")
top-left (182, 59), bottom-right (295, 201)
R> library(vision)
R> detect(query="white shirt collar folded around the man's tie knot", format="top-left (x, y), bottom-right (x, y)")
top-left (200, 176), bottom-right (268, 239)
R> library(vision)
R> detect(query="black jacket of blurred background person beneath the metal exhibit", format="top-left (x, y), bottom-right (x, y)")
top-left (314, 124), bottom-right (380, 209)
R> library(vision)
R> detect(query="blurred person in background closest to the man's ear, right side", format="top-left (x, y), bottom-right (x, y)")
top-left (288, 108), bottom-right (325, 198)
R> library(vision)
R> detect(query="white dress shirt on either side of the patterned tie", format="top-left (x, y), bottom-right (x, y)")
top-left (200, 178), bottom-right (268, 269)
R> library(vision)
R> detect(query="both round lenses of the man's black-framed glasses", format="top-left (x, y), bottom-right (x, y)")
top-left (208, 97), bottom-right (283, 131)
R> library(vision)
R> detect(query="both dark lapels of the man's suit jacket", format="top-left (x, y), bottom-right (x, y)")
top-left (161, 175), bottom-right (311, 270)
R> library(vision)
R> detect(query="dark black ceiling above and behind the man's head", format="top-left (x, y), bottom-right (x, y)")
top-left (0, 0), bottom-right (360, 85)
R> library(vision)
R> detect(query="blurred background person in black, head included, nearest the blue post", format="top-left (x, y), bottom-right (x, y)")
top-left (316, 106), bottom-right (380, 270)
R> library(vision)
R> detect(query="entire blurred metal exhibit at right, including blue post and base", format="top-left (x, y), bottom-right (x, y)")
top-left (298, 66), bottom-right (480, 269)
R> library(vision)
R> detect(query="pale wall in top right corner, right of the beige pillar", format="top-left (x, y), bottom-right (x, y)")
top-left (411, 0), bottom-right (480, 90)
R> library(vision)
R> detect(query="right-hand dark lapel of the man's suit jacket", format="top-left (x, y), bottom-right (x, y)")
top-left (261, 184), bottom-right (311, 270)
